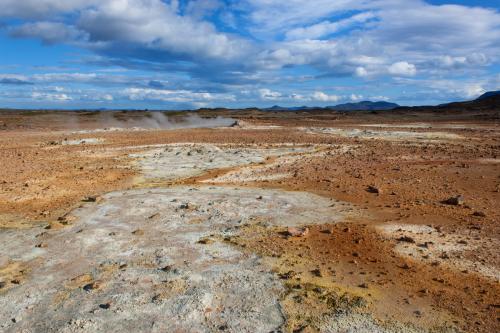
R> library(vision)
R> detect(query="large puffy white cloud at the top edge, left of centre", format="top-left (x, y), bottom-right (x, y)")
top-left (77, 0), bottom-right (249, 60)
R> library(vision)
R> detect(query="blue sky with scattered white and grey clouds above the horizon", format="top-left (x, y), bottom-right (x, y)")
top-left (0, 0), bottom-right (500, 109)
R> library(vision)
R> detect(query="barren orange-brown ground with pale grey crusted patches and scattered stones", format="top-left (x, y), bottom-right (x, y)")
top-left (0, 115), bottom-right (500, 332)
